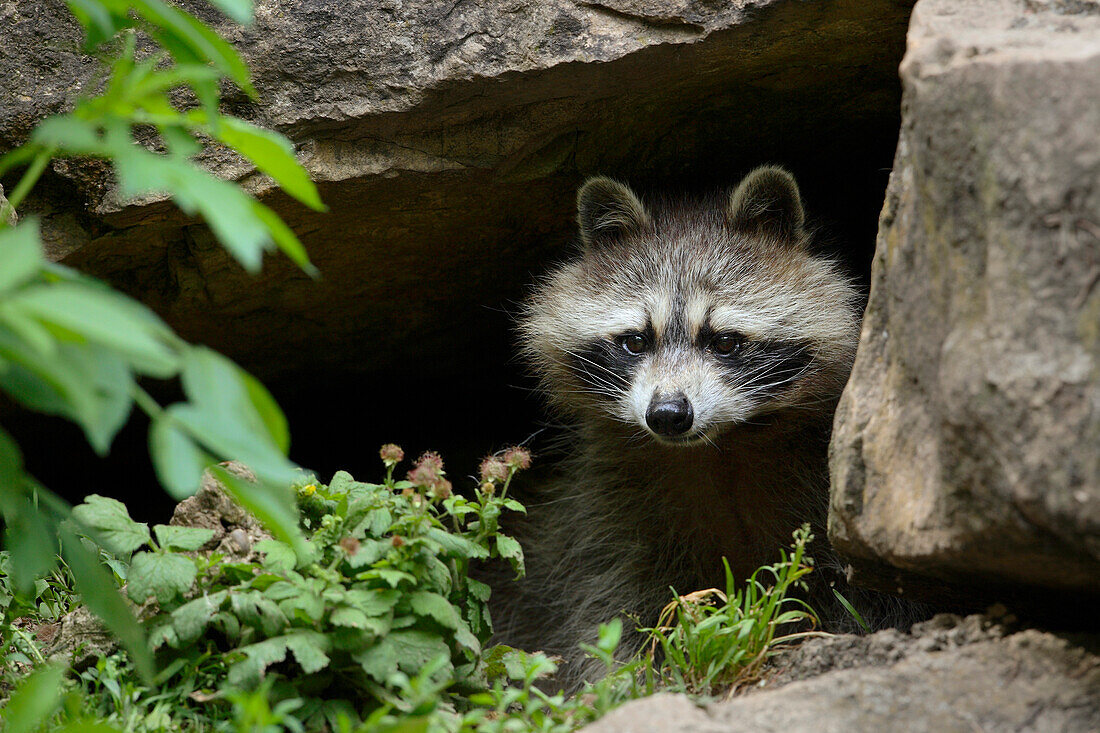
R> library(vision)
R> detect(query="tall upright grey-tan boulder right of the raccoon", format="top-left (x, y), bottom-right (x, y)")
top-left (829, 0), bottom-right (1100, 603)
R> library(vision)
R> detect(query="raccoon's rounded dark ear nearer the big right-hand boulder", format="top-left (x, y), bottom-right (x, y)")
top-left (726, 165), bottom-right (805, 237)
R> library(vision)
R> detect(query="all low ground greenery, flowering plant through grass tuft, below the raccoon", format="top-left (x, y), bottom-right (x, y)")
top-left (0, 447), bottom-right (827, 733)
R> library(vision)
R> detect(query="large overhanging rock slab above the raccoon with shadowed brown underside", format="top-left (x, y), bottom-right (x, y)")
top-left (0, 0), bottom-right (912, 379)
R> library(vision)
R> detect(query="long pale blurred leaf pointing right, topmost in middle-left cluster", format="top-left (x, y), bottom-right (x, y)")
top-left (9, 282), bottom-right (177, 378)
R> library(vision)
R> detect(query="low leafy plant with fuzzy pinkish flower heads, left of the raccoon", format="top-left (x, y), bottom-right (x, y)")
top-left (58, 445), bottom-right (530, 730)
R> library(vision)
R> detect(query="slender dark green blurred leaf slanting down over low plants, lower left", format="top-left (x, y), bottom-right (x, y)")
top-left (62, 527), bottom-right (154, 685)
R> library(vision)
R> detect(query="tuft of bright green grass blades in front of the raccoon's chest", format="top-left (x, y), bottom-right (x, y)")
top-left (642, 525), bottom-right (820, 696)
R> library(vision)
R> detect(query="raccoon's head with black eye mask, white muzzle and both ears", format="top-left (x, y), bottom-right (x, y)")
top-left (523, 168), bottom-right (858, 446)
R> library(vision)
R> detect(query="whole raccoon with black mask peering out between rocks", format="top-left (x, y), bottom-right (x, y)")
top-left (494, 167), bottom-right (915, 685)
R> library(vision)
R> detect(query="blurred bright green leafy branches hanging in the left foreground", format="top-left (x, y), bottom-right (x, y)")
top-left (0, 0), bottom-right (323, 679)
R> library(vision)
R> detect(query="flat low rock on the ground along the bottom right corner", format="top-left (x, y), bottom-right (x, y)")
top-left (584, 616), bottom-right (1100, 733)
